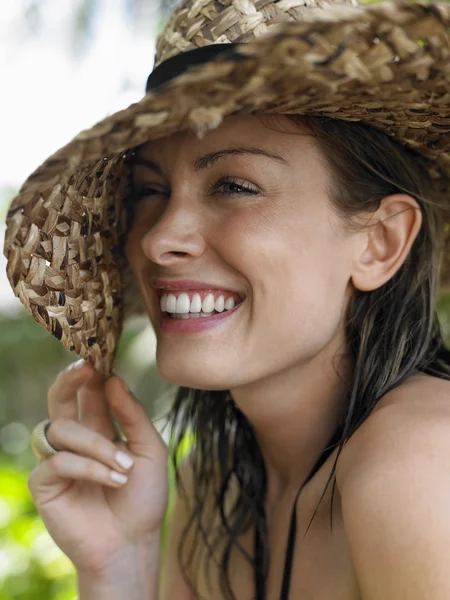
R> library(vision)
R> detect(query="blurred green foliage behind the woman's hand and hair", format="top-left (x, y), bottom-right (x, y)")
top-left (0, 311), bottom-right (179, 600)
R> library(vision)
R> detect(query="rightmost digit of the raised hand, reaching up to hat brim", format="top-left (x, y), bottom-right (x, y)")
top-left (105, 375), bottom-right (167, 460)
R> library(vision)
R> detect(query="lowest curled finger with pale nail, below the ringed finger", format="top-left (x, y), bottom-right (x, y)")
top-left (28, 450), bottom-right (128, 505)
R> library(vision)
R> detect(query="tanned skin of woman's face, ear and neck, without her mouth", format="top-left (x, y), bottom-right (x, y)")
top-left (127, 112), bottom-right (421, 507)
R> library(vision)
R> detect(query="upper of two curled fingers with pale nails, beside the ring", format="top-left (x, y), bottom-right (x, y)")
top-left (47, 419), bottom-right (134, 472)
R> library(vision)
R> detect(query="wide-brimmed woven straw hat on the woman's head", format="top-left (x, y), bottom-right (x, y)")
top-left (4, 0), bottom-right (450, 374)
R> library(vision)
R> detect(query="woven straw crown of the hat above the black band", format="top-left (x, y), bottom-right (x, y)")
top-left (155, 0), bottom-right (359, 67)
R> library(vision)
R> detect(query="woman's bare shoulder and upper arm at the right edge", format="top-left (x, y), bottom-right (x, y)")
top-left (336, 375), bottom-right (450, 600)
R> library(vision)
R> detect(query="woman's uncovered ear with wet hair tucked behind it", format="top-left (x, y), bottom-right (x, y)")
top-left (351, 194), bottom-right (422, 292)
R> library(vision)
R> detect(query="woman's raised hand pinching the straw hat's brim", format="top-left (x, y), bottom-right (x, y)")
top-left (28, 363), bottom-right (168, 574)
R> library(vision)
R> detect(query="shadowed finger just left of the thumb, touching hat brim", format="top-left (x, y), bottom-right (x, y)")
top-left (78, 371), bottom-right (120, 441)
